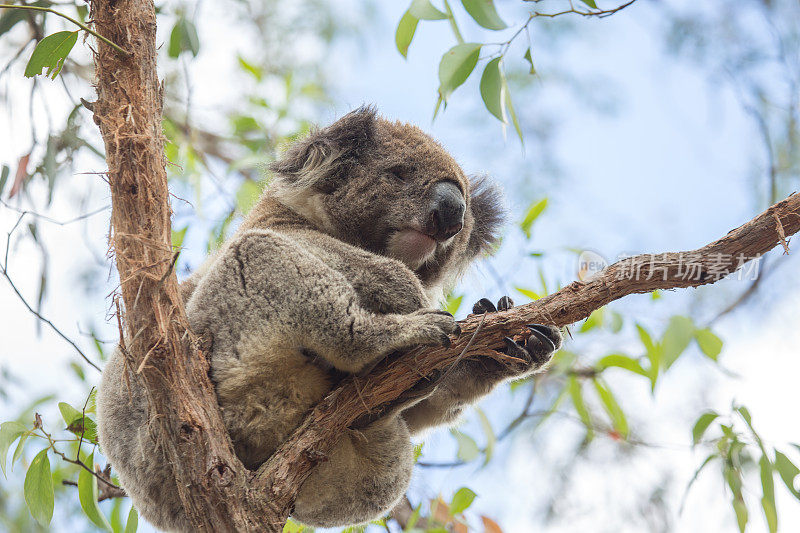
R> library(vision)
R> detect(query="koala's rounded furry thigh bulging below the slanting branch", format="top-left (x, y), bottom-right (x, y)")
top-left (292, 416), bottom-right (414, 527)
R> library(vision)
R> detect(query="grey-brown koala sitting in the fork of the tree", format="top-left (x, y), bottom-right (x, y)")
top-left (98, 108), bottom-right (562, 531)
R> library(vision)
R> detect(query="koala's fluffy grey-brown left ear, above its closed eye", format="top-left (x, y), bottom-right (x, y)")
top-left (269, 106), bottom-right (377, 188)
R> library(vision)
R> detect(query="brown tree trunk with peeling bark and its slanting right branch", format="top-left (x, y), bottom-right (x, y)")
top-left (91, 0), bottom-right (800, 532)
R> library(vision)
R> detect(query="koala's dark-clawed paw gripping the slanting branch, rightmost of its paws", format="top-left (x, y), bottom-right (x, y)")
top-left (472, 296), bottom-right (562, 374)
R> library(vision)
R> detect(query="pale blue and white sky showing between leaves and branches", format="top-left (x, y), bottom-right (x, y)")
top-left (0, 2), bottom-right (800, 532)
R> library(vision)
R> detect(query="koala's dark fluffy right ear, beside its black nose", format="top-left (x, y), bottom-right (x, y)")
top-left (467, 176), bottom-right (506, 257)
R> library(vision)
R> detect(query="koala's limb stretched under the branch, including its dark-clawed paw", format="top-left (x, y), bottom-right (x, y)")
top-left (402, 296), bottom-right (561, 435)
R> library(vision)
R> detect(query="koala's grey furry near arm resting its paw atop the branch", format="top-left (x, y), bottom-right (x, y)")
top-left (188, 230), bottom-right (458, 372)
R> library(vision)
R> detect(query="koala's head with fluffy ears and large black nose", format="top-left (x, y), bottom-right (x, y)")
top-left (271, 108), bottom-right (503, 285)
